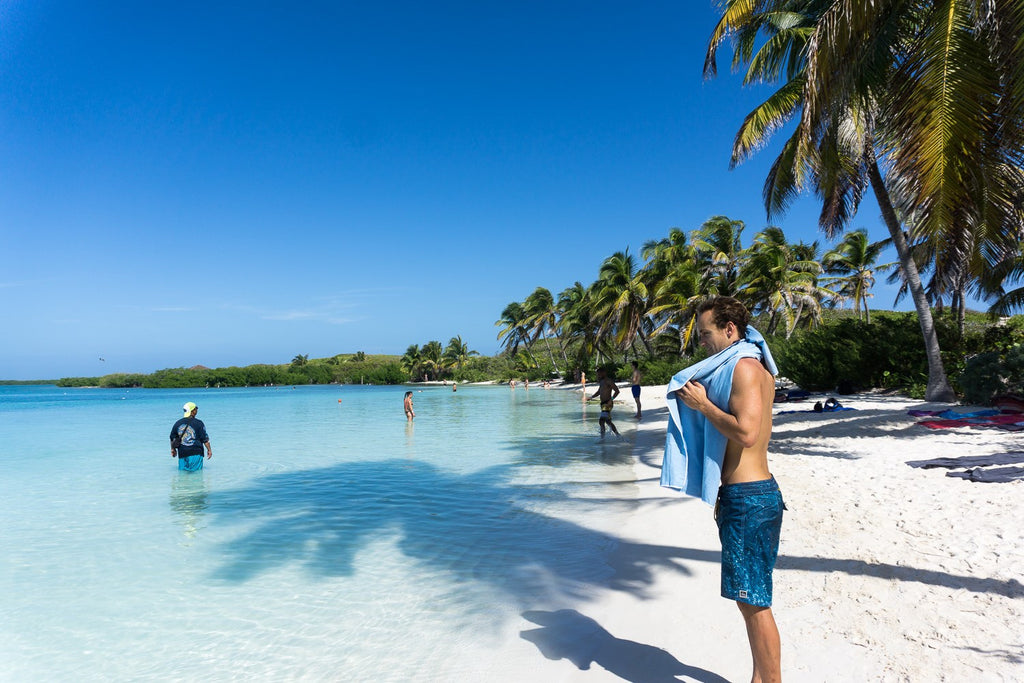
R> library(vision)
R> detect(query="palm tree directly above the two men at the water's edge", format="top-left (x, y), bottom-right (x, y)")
top-left (594, 249), bottom-right (653, 355)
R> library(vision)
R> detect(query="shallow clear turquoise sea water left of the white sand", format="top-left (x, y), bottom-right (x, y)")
top-left (0, 386), bottom-right (634, 681)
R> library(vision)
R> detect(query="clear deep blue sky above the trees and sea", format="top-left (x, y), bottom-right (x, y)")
top-left (0, 0), bottom-right (906, 379)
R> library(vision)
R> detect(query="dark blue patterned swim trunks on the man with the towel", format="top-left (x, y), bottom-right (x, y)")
top-left (715, 477), bottom-right (785, 607)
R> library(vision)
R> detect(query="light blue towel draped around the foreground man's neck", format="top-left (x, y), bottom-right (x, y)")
top-left (662, 326), bottom-right (778, 505)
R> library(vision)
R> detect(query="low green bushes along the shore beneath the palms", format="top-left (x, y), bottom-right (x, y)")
top-left (49, 310), bottom-right (1024, 411)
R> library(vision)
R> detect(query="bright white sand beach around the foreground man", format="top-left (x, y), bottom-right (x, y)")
top-left (490, 387), bottom-right (1024, 683)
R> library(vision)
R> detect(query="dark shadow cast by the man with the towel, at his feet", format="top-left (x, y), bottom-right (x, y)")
top-left (519, 609), bottom-right (728, 683)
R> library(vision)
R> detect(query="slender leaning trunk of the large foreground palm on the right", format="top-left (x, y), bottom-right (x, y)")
top-left (867, 157), bottom-right (956, 403)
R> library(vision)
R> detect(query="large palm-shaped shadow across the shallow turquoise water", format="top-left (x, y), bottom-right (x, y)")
top-left (210, 460), bottom-right (718, 604)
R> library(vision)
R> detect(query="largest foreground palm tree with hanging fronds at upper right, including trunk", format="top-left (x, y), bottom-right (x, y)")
top-left (705, 0), bottom-right (1024, 400)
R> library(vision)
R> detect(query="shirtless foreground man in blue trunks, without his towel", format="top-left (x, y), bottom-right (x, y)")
top-left (676, 297), bottom-right (783, 683)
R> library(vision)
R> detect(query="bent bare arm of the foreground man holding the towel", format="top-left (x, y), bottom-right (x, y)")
top-left (676, 358), bottom-right (765, 449)
